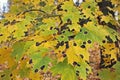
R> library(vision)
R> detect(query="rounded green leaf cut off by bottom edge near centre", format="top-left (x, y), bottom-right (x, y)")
top-left (51, 60), bottom-right (77, 80)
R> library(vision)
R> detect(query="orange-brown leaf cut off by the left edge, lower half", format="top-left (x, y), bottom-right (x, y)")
top-left (0, 48), bottom-right (16, 80)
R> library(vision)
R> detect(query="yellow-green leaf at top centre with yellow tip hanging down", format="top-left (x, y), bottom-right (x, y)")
top-left (58, 0), bottom-right (82, 32)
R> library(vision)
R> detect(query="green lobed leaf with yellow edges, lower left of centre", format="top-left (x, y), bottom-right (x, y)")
top-left (30, 47), bottom-right (52, 70)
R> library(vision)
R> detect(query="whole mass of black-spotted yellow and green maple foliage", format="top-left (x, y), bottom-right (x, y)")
top-left (0, 0), bottom-right (120, 80)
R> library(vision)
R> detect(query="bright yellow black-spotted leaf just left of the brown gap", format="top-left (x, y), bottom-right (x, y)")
top-left (66, 41), bottom-right (89, 64)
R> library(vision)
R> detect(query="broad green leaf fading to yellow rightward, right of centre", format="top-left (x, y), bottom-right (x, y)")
top-left (75, 22), bottom-right (117, 44)
